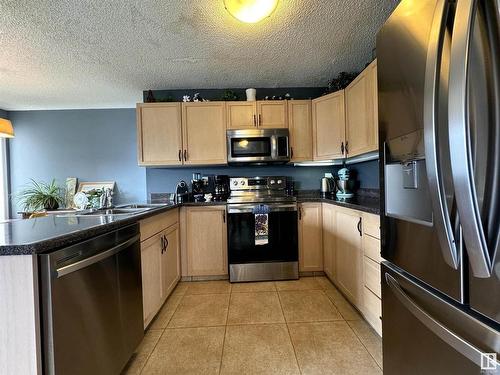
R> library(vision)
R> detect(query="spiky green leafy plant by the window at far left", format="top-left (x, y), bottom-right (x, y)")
top-left (17, 179), bottom-right (64, 211)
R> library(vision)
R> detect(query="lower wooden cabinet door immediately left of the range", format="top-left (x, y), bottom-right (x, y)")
top-left (185, 206), bottom-right (228, 276)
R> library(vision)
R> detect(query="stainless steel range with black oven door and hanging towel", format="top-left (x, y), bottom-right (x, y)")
top-left (227, 177), bottom-right (299, 282)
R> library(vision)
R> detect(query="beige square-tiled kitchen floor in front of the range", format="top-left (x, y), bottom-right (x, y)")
top-left (124, 277), bottom-right (382, 375)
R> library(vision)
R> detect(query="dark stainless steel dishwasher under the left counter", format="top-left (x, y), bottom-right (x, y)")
top-left (40, 224), bottom-right (144, 375)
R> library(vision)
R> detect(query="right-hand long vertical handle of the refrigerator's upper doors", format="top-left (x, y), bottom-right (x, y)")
top-left (448, 0), bottom-right (491, 278)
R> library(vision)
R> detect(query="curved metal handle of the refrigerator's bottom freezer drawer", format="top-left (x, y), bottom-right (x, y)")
top-left (385, 273), bottom-right (500, 366)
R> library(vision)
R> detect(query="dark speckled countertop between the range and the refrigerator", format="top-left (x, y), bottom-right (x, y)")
top-left (297, 190), bottom-right (380, 215)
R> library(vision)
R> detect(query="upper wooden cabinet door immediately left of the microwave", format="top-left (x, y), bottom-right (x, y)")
top-left (182, 102), bottom-right (227, 165)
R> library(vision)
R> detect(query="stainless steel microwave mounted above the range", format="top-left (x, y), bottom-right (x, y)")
top-left (227, 129), bottom-right (290, 164)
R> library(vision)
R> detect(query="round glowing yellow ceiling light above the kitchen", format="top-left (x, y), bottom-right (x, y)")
top-left (224, 0), bottom-right (278, 23)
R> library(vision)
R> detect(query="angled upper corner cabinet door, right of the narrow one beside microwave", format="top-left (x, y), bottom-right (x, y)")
top-left (312, 90), bottom-right (345, 160)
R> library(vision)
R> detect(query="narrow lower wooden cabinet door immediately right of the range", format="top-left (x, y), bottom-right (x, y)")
top-left (299, 203), bottom-right (323, 272)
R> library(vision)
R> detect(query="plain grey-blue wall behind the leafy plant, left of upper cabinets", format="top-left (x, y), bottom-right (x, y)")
top-left (9, 108), bottom-right (146, 216)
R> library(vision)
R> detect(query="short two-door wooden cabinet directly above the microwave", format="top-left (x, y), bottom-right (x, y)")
top-left (226, 100), bottom-right (288, 129)
